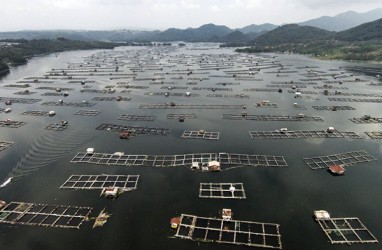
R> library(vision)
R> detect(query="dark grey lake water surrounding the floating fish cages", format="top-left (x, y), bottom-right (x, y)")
top-left (0, 44), bottom-right (382, 250)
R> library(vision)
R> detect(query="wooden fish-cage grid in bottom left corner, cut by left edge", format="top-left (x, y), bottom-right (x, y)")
top-left (0, 202), bottom-right (92, 229)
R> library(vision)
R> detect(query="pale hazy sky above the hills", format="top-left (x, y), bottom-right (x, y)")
top-left (0, 0), bottom-right (382, 31)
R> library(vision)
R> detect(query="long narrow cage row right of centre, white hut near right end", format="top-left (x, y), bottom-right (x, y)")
top-left (249, 130), bottom-right (362, 139)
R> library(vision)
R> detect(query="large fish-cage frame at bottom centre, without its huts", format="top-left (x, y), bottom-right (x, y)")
top-left (175, 214), bottom-right (282, 249)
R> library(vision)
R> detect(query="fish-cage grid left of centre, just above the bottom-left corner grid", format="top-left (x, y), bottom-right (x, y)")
top-left (60, 174), bottom-right (139, 191)
